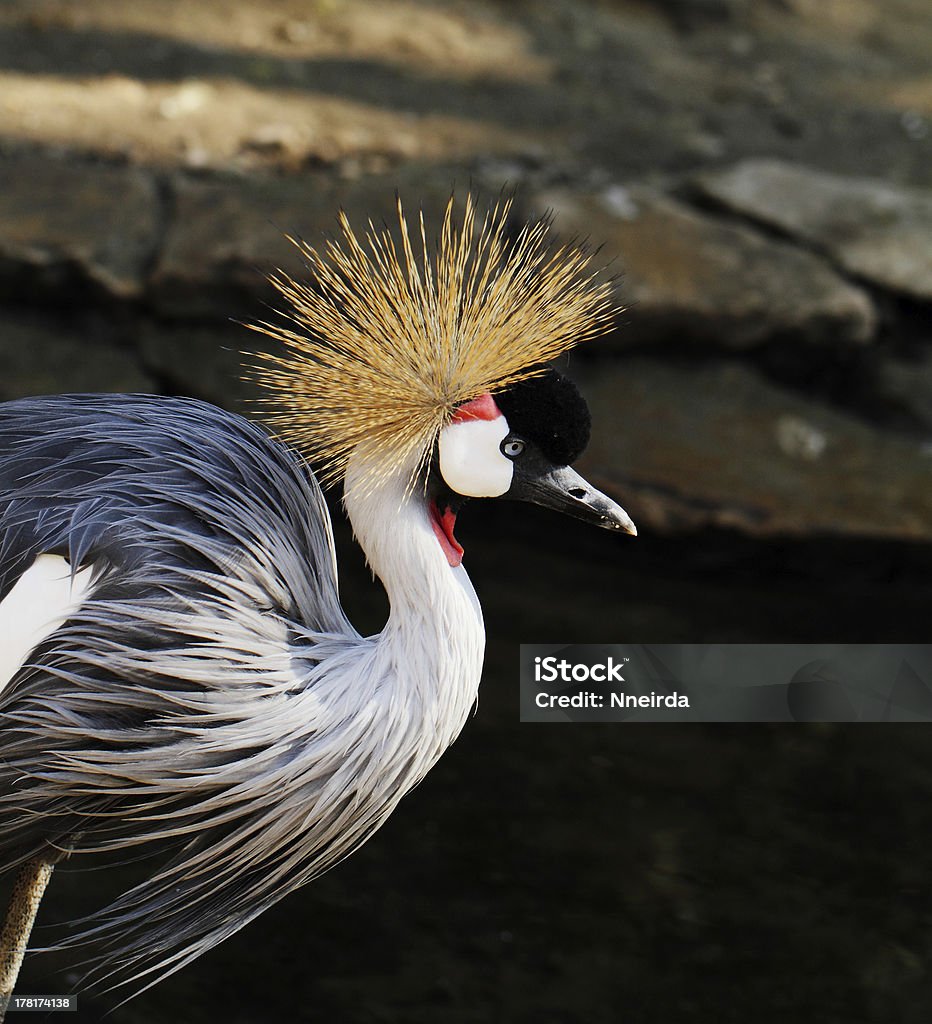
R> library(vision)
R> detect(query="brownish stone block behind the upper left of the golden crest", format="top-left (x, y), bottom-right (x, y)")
top-left (151, 169), bottom-right (458, 321)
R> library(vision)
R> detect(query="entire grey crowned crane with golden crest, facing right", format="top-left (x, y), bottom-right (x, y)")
top-left (0, 200), bottom-right (635, 1011)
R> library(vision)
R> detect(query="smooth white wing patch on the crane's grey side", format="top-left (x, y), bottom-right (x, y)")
top-left (0, 555), bottom-right (92, 690)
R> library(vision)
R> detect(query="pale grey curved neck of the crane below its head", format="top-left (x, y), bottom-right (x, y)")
top-left (344, 459), bottom-right (485, 761)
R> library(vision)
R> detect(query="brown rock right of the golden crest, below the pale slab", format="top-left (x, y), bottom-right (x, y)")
top-left (533, 185), bottom-right (876, 349)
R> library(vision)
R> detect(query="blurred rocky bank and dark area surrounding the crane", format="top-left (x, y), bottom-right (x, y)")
top-left (0, 0), bottom-right (932, 1024)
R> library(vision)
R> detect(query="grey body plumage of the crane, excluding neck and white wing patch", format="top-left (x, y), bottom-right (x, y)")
top-left (0, 395), bottom-right (405, 991)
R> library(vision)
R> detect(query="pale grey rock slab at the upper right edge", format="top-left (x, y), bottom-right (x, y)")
top-left (696, 160), bottom-right (932, 302)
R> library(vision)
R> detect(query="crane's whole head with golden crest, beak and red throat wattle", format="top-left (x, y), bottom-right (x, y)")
top-left (245, 196), bottom-right (635, 564)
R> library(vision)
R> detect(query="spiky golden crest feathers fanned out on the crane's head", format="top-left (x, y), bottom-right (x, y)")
top-left (248, 196), bottom-right (616, 495)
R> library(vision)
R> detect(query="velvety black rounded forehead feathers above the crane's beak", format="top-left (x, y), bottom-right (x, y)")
top-left (495, 369), bottom-right (592, 466)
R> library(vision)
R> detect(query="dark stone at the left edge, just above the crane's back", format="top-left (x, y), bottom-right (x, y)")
top-left (0, 311), bottom-right (155, 401)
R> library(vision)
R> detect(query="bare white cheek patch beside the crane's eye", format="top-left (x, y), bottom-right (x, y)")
top-left (439, 415), bottom-right (514, 498)
